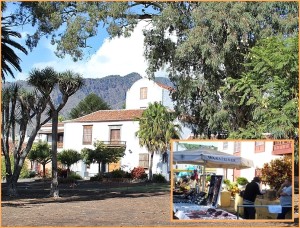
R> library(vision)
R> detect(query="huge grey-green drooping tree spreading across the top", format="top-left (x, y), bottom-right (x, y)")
top-left (8, 2), bottom-right (298, 138)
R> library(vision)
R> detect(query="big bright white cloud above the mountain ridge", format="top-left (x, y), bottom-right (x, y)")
top-left (29, 22), bottom-right (166, 78)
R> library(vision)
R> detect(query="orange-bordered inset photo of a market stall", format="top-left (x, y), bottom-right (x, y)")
top-left (171, 140), bottom-right (296, 222)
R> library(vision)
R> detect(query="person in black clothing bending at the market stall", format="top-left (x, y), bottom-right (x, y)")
top-left (243, 177), bottom-right (263, 219)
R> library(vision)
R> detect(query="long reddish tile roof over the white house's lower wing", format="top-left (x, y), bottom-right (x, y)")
top-left (65, 109), bottom-right (144, 123)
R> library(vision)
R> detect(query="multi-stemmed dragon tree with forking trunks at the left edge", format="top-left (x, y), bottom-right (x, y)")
top-left (1, 84), bottom-right (51, 196)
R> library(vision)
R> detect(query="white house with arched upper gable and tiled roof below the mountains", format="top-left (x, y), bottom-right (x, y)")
top-left (63, 79), bottom-right (190, 179)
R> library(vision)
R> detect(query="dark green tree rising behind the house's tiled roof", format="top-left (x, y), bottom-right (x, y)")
top-left (70, 93), bottom-right (110, 119)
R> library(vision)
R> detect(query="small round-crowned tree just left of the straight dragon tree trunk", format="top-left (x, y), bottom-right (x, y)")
top-left (28, 141), bottom-right (52, 178)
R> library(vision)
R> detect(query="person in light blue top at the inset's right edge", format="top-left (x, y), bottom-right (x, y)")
top-left (277, 179), bottom-right (293, 219)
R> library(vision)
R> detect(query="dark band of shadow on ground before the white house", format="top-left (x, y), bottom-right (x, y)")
top-left (2, 181), bottom-right (170, 207)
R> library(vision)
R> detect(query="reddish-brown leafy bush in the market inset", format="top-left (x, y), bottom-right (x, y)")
top-left (261, 156), bottom-right (292, 190)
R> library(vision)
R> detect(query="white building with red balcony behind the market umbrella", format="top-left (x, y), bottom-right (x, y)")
top-left (173, 140), bottom-right (293, 186)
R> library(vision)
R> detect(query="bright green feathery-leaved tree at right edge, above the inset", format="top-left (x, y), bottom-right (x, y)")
top-left (226, 36), bottom-right (299, 139)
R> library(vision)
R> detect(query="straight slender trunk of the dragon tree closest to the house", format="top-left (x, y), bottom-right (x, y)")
top-left (50, 110), bottom-right (59, 198)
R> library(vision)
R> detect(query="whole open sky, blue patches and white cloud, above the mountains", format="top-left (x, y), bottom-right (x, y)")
top-left (6, 3), bottom-right (165, 81)
